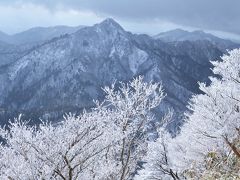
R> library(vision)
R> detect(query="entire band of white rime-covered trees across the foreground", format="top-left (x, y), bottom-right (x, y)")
top-left (0, 49), bottom-right (240, 180)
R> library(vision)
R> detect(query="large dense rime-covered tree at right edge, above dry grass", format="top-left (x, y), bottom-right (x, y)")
top-left (173, 49), bottom-right (240, 178)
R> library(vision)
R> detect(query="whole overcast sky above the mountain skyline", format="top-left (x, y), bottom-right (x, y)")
top-left (0, 0), bottom-right (240, 39)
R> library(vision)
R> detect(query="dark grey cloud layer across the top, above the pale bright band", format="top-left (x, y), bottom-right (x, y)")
top-left (1, 0), bottom-right (240, 34)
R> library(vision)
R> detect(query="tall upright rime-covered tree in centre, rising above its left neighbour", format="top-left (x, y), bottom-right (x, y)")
top-left (104, 77), bottom-right (164, 180)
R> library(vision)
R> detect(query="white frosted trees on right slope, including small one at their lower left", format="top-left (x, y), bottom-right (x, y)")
top-left (140, 49), bottom-right (240, 179)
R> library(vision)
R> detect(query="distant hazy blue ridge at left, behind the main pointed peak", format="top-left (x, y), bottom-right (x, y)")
top-left (0, 26), bottom-right (84, 74)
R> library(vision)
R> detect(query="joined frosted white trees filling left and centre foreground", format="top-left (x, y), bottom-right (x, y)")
top-left (0, 77), bottom-right (165, 180)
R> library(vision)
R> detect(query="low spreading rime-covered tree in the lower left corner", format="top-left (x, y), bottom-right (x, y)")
top-left (0, 111), bottom-right (115, 179)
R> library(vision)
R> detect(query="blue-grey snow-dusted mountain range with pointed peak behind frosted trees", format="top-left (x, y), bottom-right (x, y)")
top-left (0, 19), bottom-right (239, 130)
